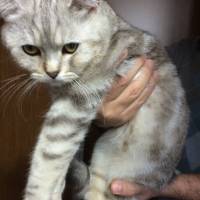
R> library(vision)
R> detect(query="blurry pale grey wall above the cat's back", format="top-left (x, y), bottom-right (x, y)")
top-left (108, 0), bottom-right (193, 45)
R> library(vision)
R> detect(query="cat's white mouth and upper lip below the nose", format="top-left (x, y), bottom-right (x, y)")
top-left (31, 72), bottom-right (79, 86)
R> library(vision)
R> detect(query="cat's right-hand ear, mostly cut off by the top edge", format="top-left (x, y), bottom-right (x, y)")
top-left (69, 0), bottom-right (101, 9)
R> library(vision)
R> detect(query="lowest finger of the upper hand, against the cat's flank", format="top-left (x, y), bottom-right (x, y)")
top-left (122, 72), bottom-right (159, 121)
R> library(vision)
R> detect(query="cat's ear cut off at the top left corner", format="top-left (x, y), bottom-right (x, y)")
top-left (0, 0), bottom-right (25, 21)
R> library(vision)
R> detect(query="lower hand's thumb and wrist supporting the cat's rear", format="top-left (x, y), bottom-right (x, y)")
top-left (111, 174), bottom-right (200, 200)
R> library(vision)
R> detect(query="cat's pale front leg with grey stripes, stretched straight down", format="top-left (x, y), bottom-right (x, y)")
top-left (24, 99), bottom-right (93, 200)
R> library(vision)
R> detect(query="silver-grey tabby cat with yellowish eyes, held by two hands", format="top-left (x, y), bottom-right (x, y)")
top-left (0, 0), bottom-right (188, 200)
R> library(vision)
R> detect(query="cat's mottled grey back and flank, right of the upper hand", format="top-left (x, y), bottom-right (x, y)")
top-left (90, 24), bottom-right (188, 189)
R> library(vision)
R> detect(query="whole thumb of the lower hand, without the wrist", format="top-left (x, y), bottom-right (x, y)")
top-left (110, 180), bottom-right (159, 200)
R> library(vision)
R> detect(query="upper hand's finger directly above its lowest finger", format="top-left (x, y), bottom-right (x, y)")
top-left (112, 60), bottom-right (154, 109)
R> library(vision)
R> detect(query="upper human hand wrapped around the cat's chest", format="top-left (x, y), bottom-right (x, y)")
top-left (97, 57), bottom-right (158, 128)
